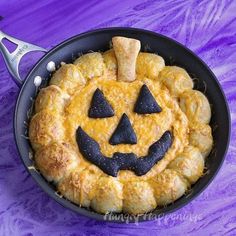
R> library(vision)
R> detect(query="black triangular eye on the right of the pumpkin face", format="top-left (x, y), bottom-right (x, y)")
top-left (134, 84), bottom-right (162, 114)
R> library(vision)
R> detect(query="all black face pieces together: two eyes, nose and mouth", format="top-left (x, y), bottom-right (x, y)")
top-left (76, 85), bottom-right (172, 176)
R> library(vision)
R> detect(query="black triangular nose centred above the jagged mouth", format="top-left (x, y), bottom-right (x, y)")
top-left (109, 113), bottom-right (137, 145)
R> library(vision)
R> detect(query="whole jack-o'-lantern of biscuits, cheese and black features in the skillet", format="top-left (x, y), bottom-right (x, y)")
top-left (29, 37), bottom-right (213, 214)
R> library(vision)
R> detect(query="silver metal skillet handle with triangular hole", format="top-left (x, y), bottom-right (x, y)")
top-left (0, 30), bottom-right (47, 86)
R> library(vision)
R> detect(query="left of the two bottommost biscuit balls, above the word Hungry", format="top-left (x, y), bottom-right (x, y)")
top-left (91, 176), bottom-right (123, 214)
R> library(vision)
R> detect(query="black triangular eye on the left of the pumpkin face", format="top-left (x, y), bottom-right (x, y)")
top-left (88, 89), bottom-right (114, 118)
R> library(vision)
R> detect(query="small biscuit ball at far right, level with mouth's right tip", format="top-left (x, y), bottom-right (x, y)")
top-left (189, 123), bottom-right (213, 158)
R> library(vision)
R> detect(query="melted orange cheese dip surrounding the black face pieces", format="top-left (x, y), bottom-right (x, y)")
top-left (64, 75), bottom-right (188, 179)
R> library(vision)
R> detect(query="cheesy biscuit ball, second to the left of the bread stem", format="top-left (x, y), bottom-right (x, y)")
top-left (74, 52), bottom-right (105, 79)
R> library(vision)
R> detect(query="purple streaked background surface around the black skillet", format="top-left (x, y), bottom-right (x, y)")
top-left (0, 0), bottom-right (236, 236)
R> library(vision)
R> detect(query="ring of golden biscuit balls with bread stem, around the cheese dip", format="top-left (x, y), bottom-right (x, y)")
top-left (29, 37), bottom-right (213, 215)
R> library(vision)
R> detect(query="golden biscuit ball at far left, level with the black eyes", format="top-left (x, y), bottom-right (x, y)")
top-left (35, 85), bottom-right (69, 113)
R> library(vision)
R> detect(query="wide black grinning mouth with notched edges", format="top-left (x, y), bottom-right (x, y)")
top-left (76, 127), bottom-right (173, 177)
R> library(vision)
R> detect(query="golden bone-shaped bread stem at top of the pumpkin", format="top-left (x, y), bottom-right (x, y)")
top-left (112, 36), bottom-right (141, 82)
